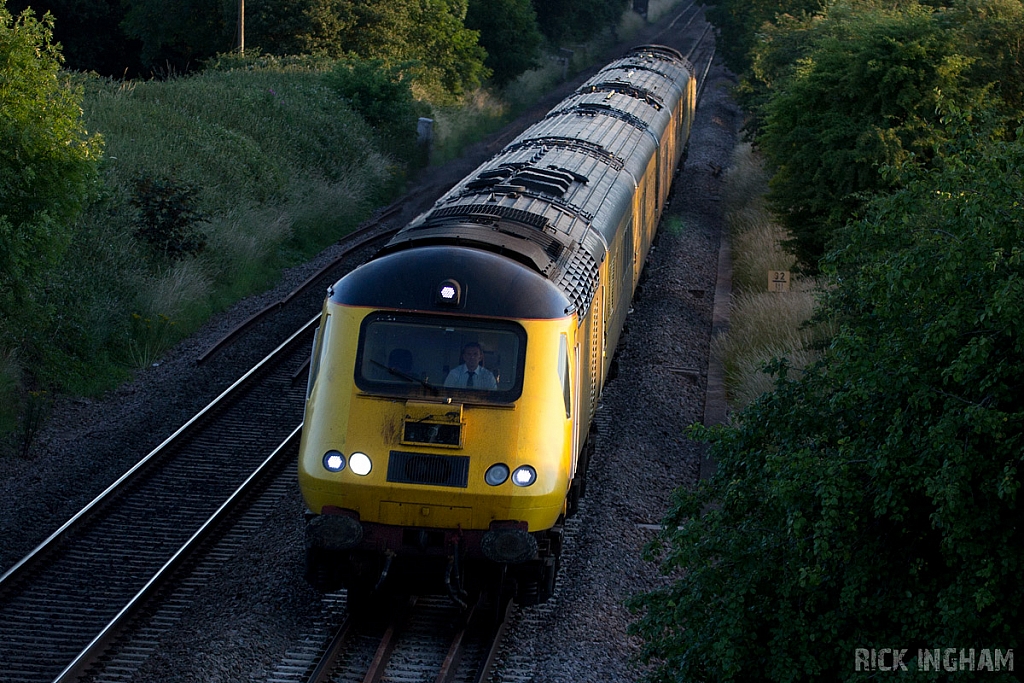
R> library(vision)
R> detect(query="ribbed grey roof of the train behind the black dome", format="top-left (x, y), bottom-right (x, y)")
top-left (356, 45), bottom-right (693, 317)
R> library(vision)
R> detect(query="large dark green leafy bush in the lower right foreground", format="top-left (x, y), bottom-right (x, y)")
top-left (633, 103), bottom-right (1024, 681)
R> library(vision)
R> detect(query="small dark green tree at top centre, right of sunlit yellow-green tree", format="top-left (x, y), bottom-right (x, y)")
top-left (466, 0), bottom-right (544, 86)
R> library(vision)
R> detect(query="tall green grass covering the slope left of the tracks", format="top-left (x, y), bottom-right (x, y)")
top-left (16, 62), bottom-right (401, 403)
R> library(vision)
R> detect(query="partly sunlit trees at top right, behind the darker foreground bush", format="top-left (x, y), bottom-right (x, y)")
top-left (712, 0), bottom-right (1024, 272)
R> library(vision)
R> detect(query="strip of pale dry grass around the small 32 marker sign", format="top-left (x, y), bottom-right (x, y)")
top-left (712, 144), bottom-right (819, 410)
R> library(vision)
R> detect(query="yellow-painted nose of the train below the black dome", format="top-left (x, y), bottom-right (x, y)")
top-left (299, 303), bottom-right (572, 530)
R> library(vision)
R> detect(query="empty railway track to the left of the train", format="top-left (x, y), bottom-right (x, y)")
top-left (0, 325), bottom-right (313, 683)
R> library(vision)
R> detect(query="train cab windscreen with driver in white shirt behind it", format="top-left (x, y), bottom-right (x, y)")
top-left (355, 314), bottom-right (526, 402)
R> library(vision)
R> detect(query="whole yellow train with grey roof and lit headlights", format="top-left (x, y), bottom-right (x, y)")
top-left (299, 45), bottom-right (696, 604)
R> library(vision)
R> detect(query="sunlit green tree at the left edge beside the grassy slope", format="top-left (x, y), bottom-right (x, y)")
top-left (0, 5), bottom-right (101, 317)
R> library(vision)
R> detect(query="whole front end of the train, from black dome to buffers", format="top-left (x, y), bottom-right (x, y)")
top-left (299, 244), bottom-right (575, 593)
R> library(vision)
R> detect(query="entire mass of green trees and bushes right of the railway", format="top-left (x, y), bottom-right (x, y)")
top-left (632, 0), bottom-right (1024, 682)
